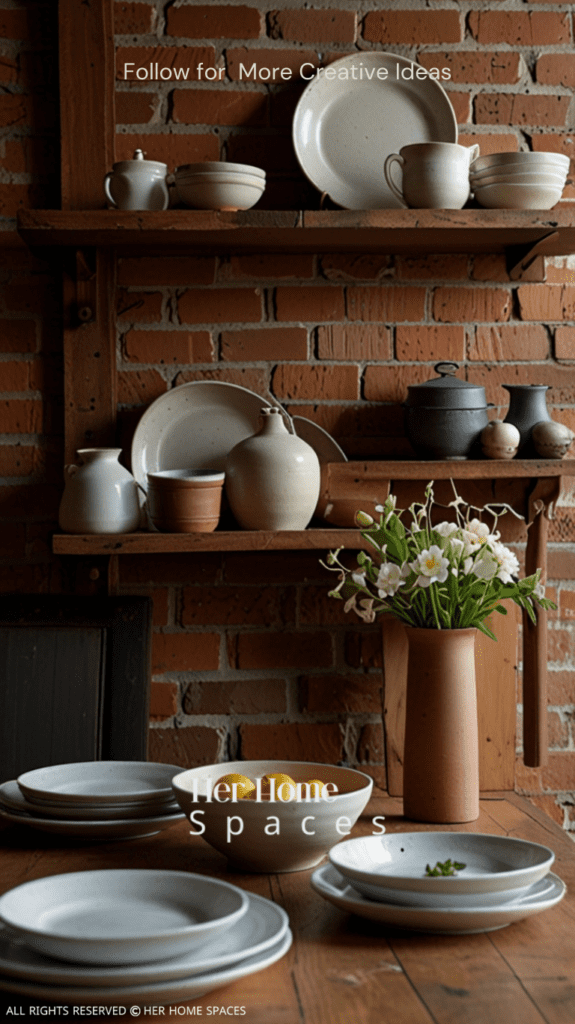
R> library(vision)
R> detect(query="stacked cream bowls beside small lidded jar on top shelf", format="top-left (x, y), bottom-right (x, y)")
top-left (174, 162), bottom-right (266, 210)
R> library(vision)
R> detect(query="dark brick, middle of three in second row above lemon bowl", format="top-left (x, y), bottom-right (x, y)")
top-left (183, 679), bottom-right (286, 715)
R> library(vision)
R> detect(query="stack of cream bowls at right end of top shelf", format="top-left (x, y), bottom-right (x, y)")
top-left (470, 153), bottom-right (569, 210)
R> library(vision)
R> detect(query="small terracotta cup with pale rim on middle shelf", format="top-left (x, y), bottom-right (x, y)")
top-left (147, 469), bottom-right (225, 534)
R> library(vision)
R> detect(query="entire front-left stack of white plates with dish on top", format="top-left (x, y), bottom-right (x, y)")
top-left (0, 869), bottom-right (292, 1007)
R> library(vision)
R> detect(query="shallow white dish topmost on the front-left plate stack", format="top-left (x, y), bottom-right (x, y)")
top-left (0, 868), bottom-right (248, 965)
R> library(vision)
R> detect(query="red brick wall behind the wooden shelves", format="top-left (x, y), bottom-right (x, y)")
top-left (0, 0), bottom-right (575, 830)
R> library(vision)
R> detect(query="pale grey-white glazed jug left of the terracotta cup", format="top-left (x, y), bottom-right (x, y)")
top-left (58, 449), bottom-right (140, 534)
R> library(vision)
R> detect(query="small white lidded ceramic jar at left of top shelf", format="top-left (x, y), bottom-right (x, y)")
top-left (103, 150), bottom-right (170, 210)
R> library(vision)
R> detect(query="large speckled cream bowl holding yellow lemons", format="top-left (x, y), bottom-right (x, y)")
top-left (172, 761), bottom-right (373, 872)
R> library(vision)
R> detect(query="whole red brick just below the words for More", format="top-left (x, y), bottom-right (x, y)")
top-left (173, 89), bottom-right (268, 128)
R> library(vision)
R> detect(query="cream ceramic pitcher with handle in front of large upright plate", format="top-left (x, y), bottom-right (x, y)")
top-left (384, 142), bottom-right (479, 210)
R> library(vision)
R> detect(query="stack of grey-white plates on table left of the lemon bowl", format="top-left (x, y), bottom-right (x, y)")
top-left (0, 761), bottom-right (184, 840)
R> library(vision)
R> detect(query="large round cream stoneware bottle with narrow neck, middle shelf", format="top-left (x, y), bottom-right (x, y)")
top-left (225, 408), bottom-right (320, 530)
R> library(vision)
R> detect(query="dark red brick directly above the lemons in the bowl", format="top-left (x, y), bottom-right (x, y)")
top-left (239, 722), bottom-right (344, 764)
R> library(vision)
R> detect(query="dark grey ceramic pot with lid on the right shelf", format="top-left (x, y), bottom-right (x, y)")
top-left (403, 362), bottom-right (488, 459)
